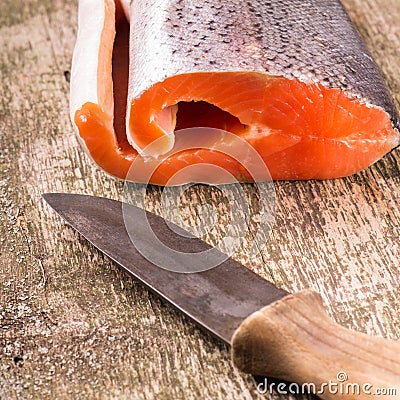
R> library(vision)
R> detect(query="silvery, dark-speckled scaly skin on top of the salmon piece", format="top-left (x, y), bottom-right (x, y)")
top-left (129, 0), bottom-right (399, 126)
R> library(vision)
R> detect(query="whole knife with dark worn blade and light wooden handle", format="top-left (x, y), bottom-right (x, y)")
top-left (43, 193), bottom-right (400, 400)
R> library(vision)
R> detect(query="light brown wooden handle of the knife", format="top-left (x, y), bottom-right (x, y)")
top-left (232, 290), bottom-right (400, 400)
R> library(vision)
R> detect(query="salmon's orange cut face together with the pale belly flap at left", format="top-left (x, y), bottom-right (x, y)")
top-left (71, 0), bottom-right (400, 185)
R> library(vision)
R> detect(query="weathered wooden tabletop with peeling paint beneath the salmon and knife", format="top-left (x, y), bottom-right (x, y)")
top-left (0, 0), bottom-right (400, 400)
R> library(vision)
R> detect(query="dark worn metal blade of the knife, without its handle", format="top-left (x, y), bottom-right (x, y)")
top-left (43, 193), bottom-right (288, 343)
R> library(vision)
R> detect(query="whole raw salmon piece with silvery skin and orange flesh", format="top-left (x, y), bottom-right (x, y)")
top-left (71, 0), bottom-right (400, 185)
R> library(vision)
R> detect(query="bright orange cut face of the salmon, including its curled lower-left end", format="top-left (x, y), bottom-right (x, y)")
top-left (76, 73), bottom-right (400, 184)
